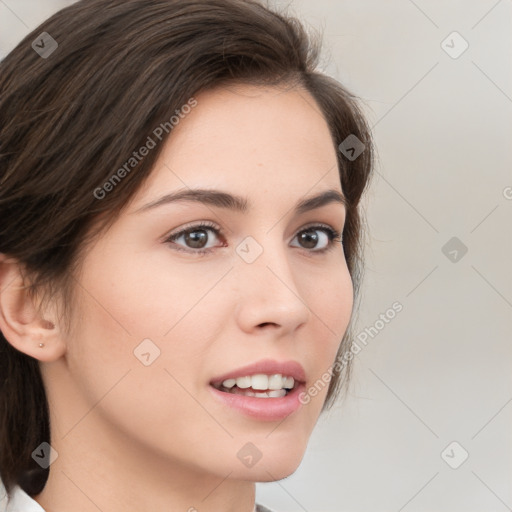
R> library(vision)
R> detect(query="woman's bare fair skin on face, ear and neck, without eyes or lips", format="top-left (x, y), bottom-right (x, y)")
top-left (0, 85), bottom-right (353, 512)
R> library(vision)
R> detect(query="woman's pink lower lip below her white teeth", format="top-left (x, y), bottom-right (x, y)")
top-left (210, 384), bottom-right (305, 421)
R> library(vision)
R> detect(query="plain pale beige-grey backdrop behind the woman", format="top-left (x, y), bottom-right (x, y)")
top-left (0, 0), bottom-right (512, 512)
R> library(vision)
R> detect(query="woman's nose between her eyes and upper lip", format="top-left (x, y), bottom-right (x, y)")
top-left (232, 239), bottom-right (312, 336)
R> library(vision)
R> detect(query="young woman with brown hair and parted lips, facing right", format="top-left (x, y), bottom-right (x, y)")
top-left (0, 0), bottom-right (373, 512)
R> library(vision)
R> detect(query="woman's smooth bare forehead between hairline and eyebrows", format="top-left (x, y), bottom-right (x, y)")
top-left (134, 85), bottom-right (341, 207)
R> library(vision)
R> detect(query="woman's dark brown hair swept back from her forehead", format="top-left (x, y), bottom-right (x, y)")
top-left (0, 0), bottom-right (373, 495)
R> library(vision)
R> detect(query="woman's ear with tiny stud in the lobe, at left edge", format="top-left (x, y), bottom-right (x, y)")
top-left (0, 253), bottom-right (66, 361)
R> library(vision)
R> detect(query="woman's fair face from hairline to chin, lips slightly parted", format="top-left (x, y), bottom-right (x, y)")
top-left (53, 86), bottom-right (353, 481)
